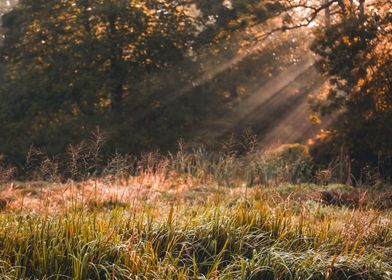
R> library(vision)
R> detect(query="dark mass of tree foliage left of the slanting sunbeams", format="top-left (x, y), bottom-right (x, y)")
top-left (0, 0), bottom-right (290, 162)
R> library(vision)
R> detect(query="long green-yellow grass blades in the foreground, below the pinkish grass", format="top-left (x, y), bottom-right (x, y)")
top-left (0, 182), bottom-right (392, 279)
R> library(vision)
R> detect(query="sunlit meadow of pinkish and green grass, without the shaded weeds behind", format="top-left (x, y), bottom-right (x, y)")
top-left (0, 149), bottom-right (392, 279)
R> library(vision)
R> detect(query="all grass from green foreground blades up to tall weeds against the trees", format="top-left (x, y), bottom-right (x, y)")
top-left (0, 137), bottom-right (392, 279)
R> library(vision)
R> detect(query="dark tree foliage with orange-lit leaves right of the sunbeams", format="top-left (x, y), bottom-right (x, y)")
top-left (312, 1), bottom-right (392, 176)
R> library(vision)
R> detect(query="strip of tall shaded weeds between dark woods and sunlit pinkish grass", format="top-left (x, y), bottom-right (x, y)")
top-left (0, 130), bottom-right (388, 187)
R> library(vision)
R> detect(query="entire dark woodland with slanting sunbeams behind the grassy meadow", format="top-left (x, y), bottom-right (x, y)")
top-left (0, 0), bottom-right (392, 179)
